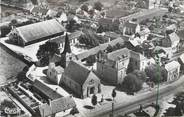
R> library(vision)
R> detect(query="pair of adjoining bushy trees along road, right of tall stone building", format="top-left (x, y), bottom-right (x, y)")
top-left (120, 59), bottom-right (167, 92)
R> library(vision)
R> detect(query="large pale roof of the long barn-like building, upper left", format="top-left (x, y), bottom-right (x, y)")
top-left (16, 19), bottom-right (65, 42)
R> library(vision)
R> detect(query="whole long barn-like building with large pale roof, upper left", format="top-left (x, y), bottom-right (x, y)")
top-left (9, 19), bottom-right (65, 46)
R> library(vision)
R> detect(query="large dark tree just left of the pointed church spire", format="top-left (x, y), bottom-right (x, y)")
top-left (36, 41), bottom-right (60, 66)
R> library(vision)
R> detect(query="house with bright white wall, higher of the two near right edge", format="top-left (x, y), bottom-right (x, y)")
top-left (161, 32), bottom-right (180, 52)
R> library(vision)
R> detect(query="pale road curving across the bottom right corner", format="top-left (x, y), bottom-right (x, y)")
top-left (86, 76), bottom-right (184, 117)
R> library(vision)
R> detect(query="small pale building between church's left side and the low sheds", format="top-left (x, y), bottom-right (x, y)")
top-left (47, 63), bottom-right (64, 85)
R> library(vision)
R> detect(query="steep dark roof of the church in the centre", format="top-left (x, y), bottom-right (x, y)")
top-left (64, 61), bottom-right (97, 85)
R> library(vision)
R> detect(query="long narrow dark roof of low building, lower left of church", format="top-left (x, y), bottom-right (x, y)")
top-left (33, 79), bottom-right (63, 100)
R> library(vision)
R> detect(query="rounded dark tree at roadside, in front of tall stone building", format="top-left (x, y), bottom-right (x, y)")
top-left (121, 73), bottom-right (143, 93)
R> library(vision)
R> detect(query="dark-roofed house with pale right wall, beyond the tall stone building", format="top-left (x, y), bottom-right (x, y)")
top-left (120, 21), bottom-right (141, 36)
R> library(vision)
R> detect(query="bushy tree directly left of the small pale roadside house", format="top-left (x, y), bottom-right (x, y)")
top-left (145, 65), bottom-right (167, 83)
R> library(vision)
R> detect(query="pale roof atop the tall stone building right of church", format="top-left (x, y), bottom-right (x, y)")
top-left (107, 48), bottom-right (130, 61)
